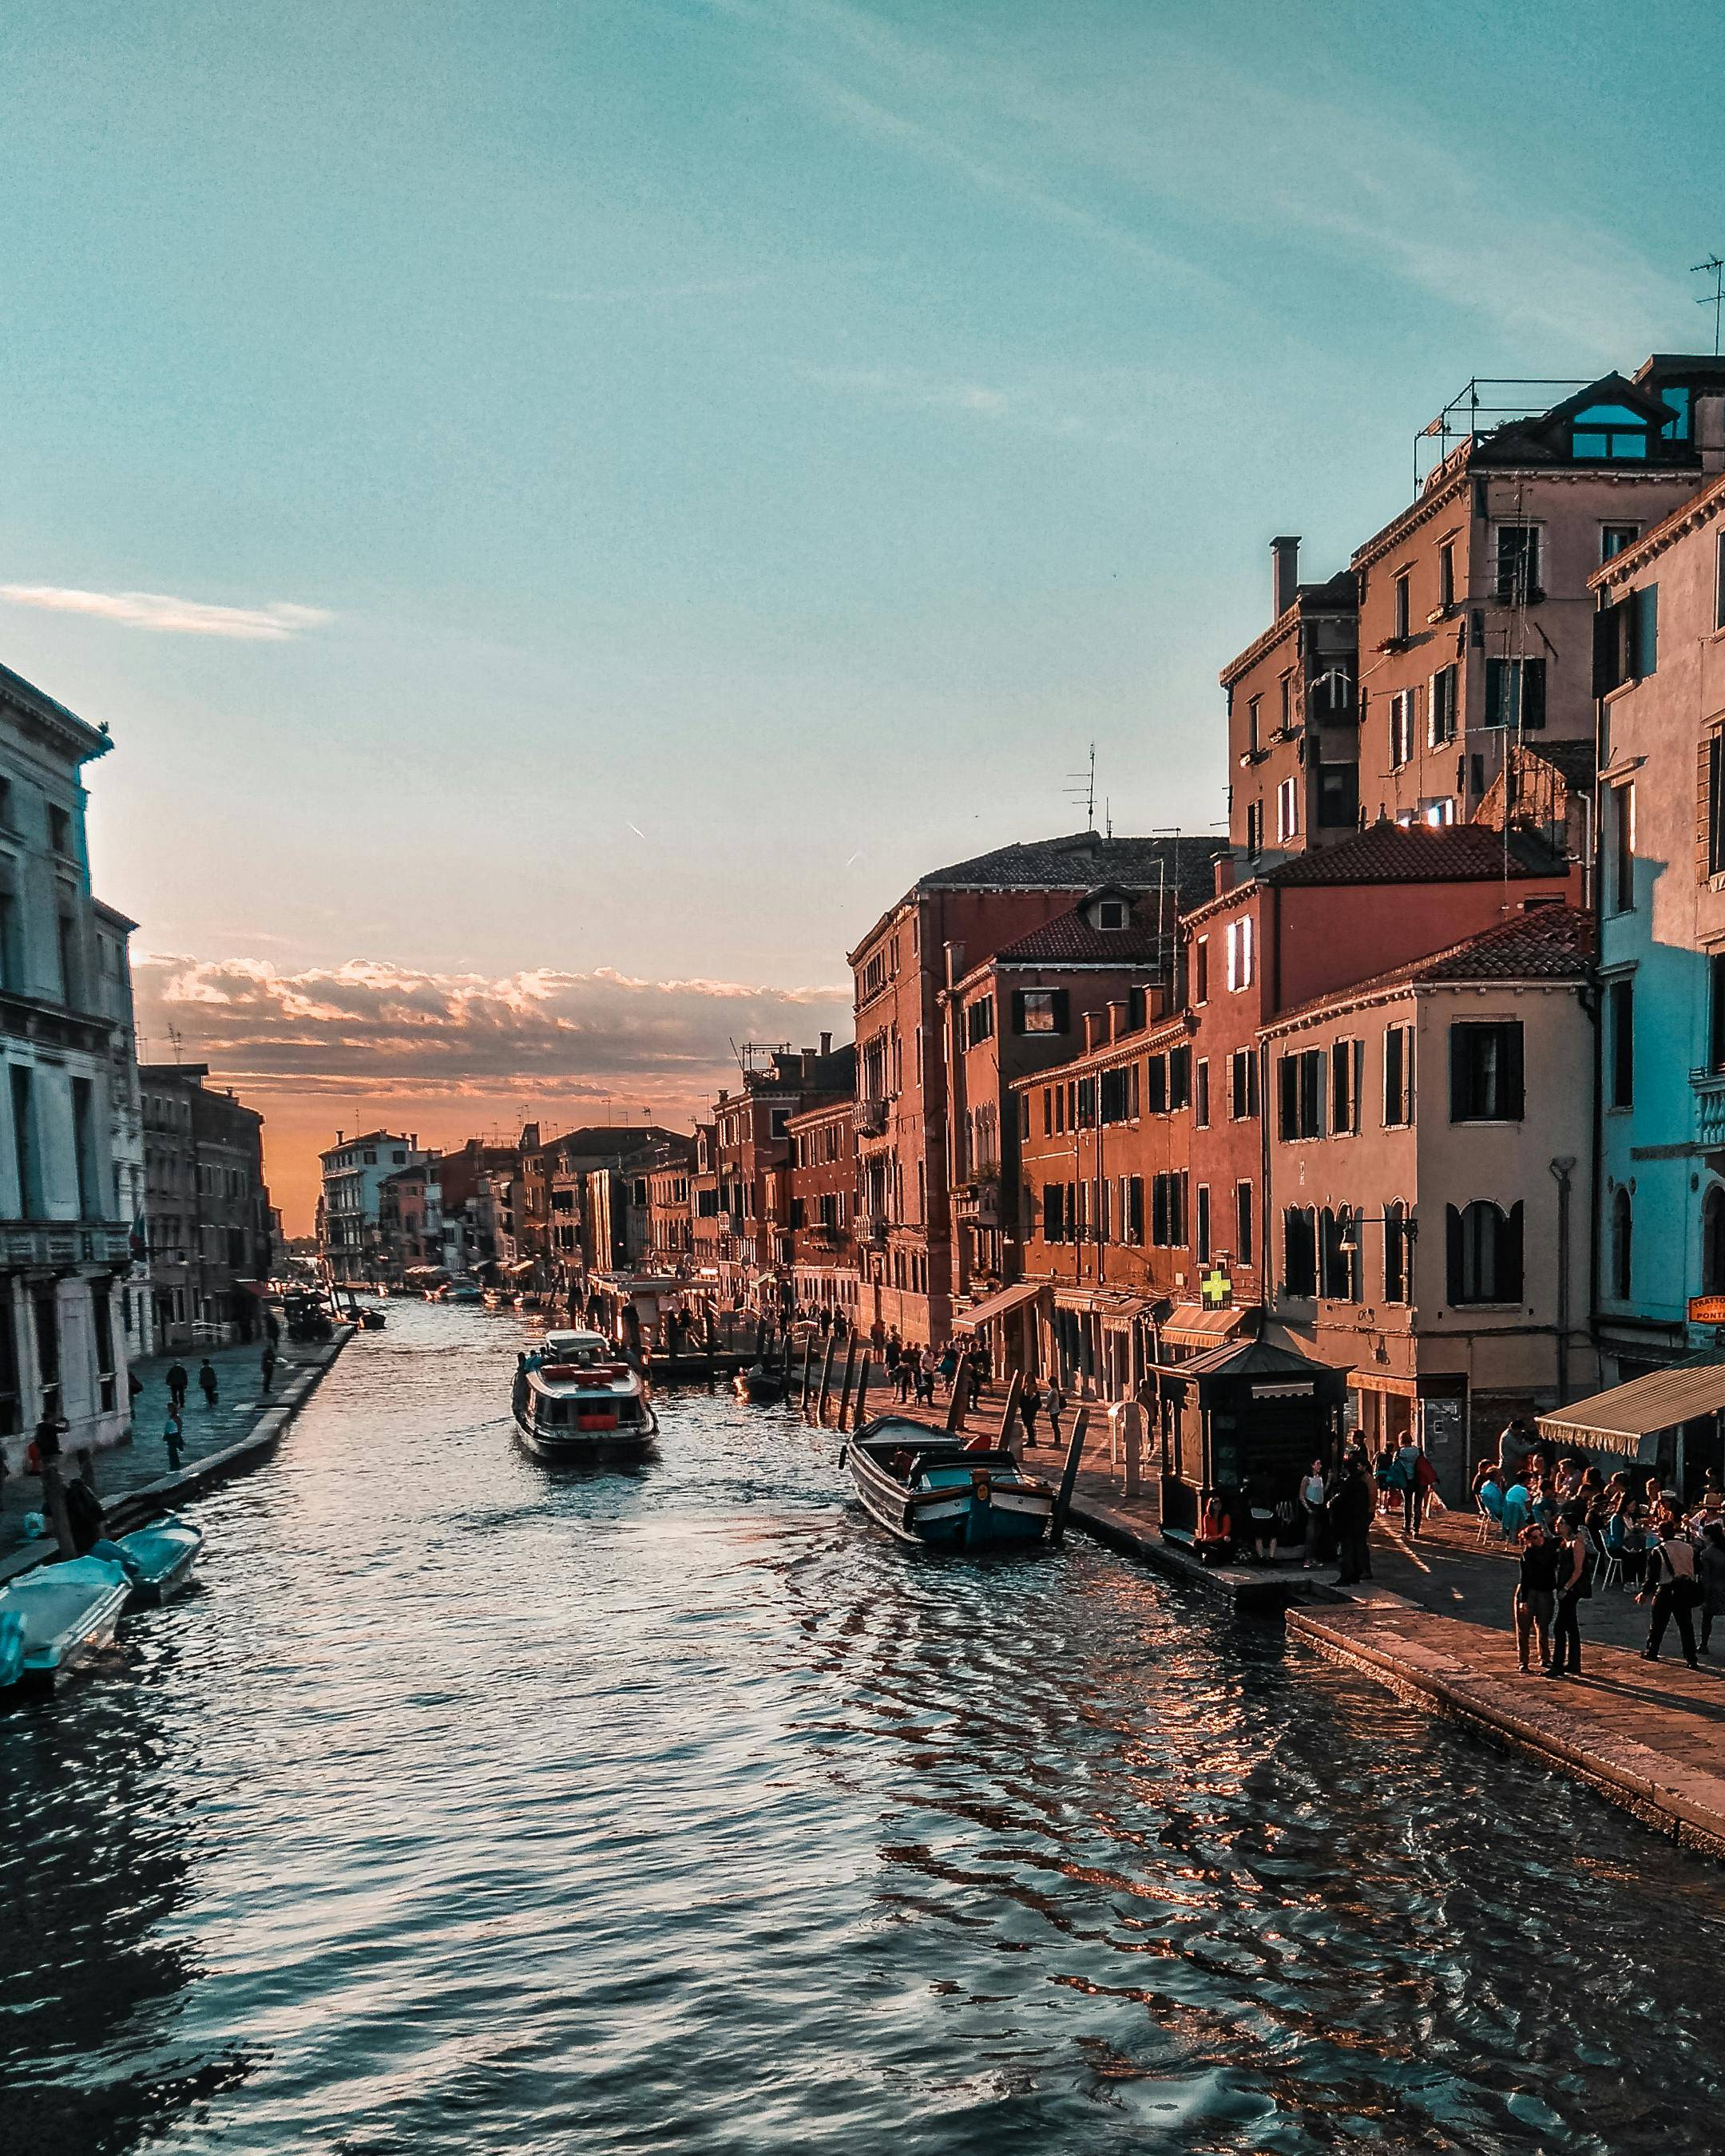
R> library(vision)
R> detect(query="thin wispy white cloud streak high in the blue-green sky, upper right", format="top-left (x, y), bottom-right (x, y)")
top-left (709, 0), bottom-right (1686, 363)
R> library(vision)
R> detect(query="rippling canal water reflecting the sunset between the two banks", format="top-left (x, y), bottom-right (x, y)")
top-left (0, 1302), bottom-right (1725, 2156)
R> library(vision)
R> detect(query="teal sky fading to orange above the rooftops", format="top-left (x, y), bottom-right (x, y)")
top-left (0, 0), bottom-right (1725, 1229)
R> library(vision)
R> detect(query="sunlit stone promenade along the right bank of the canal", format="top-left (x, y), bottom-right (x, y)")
top-left (854, 1386), bottom-right (1725, 1857)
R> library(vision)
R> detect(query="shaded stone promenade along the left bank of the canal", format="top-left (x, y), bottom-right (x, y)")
top-left (0, 1326), bottom-right (351, 1580)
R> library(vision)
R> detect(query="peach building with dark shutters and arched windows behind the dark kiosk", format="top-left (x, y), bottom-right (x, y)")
top-left (1263, 906), bottom-right (1598, 1503)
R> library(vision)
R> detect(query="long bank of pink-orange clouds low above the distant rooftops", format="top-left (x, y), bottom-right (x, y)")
top-left (133, 955), bottom-right (850, 1117)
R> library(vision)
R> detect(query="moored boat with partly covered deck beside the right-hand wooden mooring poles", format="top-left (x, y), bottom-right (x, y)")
top-left (845, 1414), bottom-right (1054, 1550)
